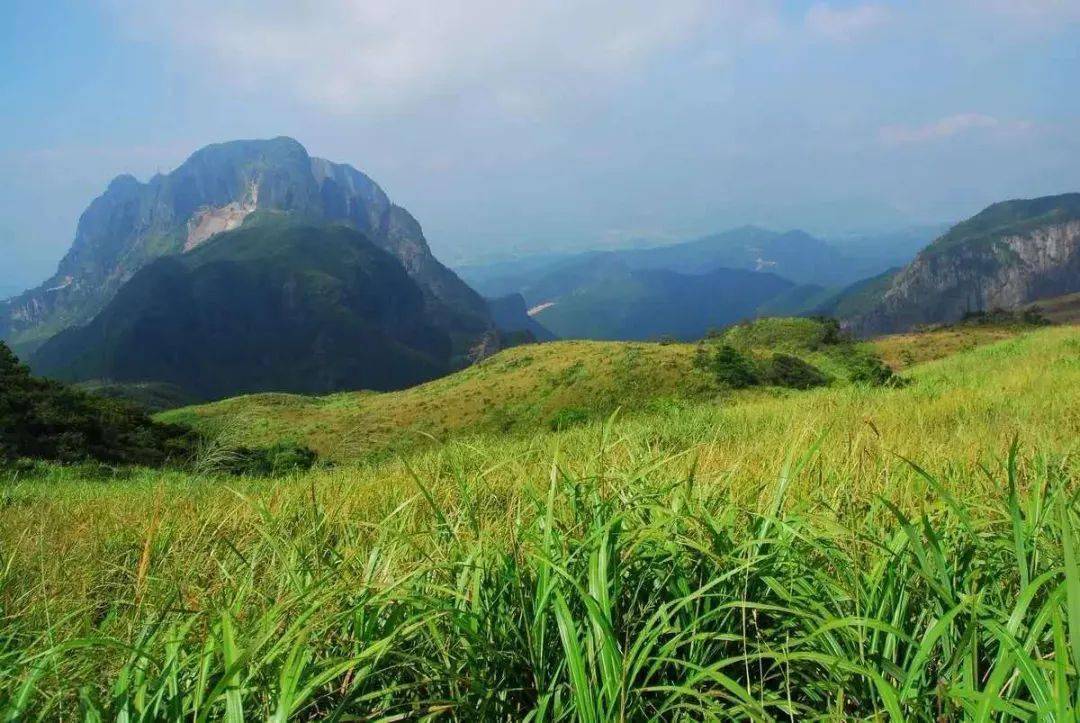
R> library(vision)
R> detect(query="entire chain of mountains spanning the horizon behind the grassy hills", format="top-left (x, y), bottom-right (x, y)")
top-left (6, 137), bottom-right (1080, 404)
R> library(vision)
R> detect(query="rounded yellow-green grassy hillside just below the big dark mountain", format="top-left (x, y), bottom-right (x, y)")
top-left (161, 342), bottom-right (713, 458)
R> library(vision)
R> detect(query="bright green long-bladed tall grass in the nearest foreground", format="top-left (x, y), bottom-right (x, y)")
top-left (0, 434), bottom-right (1080, 721)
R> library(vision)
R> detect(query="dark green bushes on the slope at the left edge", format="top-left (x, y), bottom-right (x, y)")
top-left (0, 342), bottom-right (195, 464)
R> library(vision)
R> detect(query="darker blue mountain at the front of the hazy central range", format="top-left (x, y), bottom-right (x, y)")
top-left (532, 257), bottom-right (795, 339)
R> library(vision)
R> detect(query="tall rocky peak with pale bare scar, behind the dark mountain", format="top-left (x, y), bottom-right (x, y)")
top-left (0, 137), bottom-right (490, 358)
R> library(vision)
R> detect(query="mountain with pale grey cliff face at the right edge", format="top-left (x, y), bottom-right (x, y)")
top-left (833, 193), bottom-right (1080, 336)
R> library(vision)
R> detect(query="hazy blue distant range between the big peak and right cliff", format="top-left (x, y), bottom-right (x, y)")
top-left (459, 226), bottom-right (935, 339)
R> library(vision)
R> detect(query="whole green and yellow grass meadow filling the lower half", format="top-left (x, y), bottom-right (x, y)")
top-left (0, 327), bottom-right (1080, 721)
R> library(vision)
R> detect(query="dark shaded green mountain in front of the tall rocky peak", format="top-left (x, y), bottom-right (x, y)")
top-left (30, 221), bottom-right (453, 399)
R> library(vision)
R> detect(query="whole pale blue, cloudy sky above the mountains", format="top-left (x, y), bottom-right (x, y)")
top-left (0, 0), bottom-right (1080, 295)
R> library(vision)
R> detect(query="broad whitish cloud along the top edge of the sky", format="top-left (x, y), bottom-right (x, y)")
top-left (112, 0), bottom-right (772, 116)
